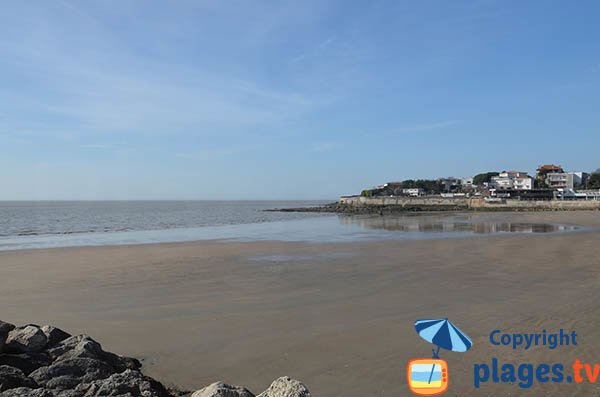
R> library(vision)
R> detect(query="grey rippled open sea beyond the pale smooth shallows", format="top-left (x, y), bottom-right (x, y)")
top-left (0, 201), bottom-right (322, 237)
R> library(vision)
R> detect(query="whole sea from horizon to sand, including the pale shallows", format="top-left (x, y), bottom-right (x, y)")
top-left (0, 201), bottom-right (576, 251)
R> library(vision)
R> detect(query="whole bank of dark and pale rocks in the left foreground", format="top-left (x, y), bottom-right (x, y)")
top-left (0, 321), bottom-right (311, 397)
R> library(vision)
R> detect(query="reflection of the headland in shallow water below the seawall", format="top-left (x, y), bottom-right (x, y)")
top-left (339, 214), bottom-right (576, 234)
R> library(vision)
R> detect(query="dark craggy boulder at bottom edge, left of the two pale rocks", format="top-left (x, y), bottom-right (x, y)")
top-left (84, 369), bottom-right (169, 397)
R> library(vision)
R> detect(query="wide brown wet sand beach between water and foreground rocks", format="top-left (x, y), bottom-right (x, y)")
top-left (0, 212), bottom-right (600, 396)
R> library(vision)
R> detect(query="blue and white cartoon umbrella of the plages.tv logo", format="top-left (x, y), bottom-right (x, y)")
top-left (415, 318), bottom-right (473, 358)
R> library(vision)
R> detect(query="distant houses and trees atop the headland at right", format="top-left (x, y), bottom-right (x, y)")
top-left (361, 164), bottom-right (600, 201)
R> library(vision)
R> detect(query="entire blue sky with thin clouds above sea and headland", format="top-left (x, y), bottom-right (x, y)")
top-left (0, 0), bottom-right (600, 200)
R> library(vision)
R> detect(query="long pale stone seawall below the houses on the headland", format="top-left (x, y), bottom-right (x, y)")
top-left (339, 196), bottom-right (600, 211)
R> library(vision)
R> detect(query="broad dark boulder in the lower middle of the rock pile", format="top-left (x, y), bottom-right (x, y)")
top-left (29, 358), bottom-right (115, 394)
